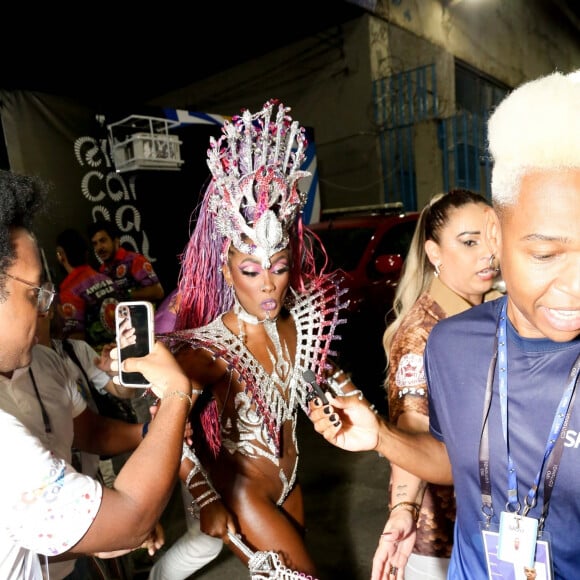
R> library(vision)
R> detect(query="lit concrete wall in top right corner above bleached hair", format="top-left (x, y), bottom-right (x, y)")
top-left (377, 0), bottom-right (580, 87)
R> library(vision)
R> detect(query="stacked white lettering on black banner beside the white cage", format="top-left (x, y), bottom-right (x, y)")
top-left (74, 136), bottom-right (157, 263)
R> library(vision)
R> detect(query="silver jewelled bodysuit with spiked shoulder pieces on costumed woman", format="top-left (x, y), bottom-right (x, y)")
top-left (169, 279), bottom-right (347, 505)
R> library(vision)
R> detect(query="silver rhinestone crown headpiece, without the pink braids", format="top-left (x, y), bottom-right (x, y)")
top-left (207, 99), bottom-right (310, 268)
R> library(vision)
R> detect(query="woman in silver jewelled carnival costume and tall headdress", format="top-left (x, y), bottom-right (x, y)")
top-left (166, 100), bottom-right (359, 578)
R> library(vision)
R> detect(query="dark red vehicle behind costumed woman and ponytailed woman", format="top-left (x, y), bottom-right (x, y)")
top-left (308, 203), bottom-right (419, 413)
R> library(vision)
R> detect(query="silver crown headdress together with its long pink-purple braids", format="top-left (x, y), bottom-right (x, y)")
top-left (175, 99), bottom-right (322, 330)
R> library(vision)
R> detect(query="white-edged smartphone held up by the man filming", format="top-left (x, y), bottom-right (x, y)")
top-left (115, 300), bottom-right (155, 388)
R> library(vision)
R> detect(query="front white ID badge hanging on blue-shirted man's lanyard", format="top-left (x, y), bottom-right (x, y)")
top-left (497, 512), bottom-right (538, 567)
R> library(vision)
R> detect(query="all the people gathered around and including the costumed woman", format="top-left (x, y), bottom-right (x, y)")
top-left (0, 68), bottom-right (580, 580)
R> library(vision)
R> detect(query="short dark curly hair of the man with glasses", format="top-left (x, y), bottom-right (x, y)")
top-left (0, 170), bottom-right (48, 290)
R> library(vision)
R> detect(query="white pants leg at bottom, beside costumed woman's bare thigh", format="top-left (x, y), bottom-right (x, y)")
top-left (149, 482), bottom-right (223, 580)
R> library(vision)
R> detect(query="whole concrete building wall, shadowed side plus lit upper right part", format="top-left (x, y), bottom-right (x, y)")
top-left (152, 0), bottom-right (580, 209)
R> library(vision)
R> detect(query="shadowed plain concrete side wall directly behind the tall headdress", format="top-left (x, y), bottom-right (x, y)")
top-left (153, 16), bottom-right (380, 207)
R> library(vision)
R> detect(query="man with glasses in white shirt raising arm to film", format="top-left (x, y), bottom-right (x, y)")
top-left (0, 171), bottom-right (192, 580)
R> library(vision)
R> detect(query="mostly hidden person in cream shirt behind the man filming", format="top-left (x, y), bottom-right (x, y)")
top-left (7, 304), bottom-right (152, 580)
